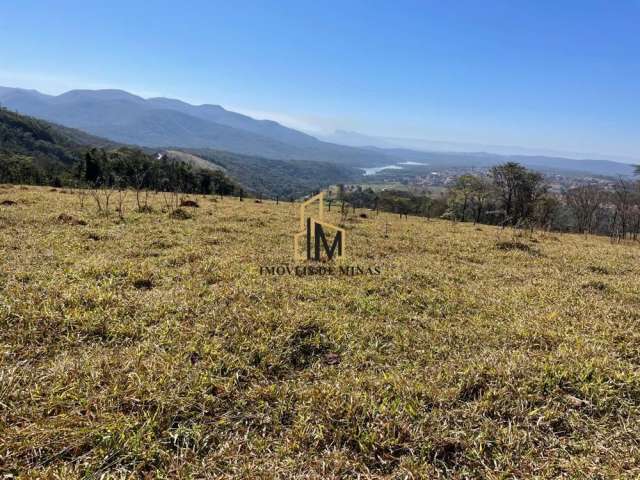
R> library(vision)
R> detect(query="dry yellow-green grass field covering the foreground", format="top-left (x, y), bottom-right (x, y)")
top-left (0, 186), bottom-right (640, 479)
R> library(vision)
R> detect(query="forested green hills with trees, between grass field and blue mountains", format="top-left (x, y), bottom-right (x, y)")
top-left (0, 108), bottom-right (360, 198)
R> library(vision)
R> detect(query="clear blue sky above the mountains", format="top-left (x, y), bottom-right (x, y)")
top-left (0, 0), bottom-right (640, 158)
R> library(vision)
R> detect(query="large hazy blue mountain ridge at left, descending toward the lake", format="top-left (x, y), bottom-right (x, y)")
top-left (0, 87), bottom-right (393, 167)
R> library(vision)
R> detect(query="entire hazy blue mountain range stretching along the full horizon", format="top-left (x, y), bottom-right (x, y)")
top-left (0, 87), bottom-right (634, 176)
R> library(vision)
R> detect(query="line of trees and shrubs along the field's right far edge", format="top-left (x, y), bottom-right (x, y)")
top-left (338, 162), bottom-right (640, 240)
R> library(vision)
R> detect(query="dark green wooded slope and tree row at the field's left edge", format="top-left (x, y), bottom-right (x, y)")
top-left (0, 108), bottom-right (240, 195)
